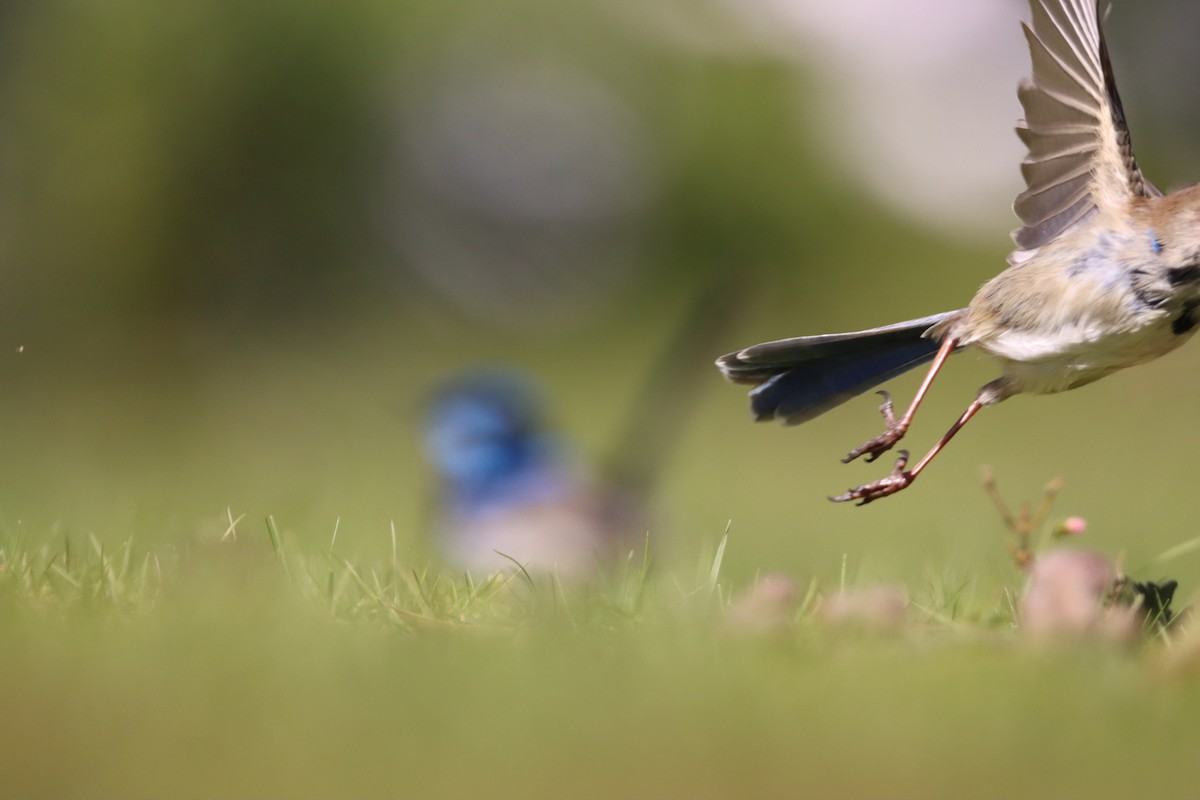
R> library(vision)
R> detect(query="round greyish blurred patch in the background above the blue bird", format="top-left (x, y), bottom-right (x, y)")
top-left (388, 58), bottom-right (656, 325)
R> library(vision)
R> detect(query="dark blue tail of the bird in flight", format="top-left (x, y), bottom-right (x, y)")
top-left (716, 311), bottom-right (960, 425)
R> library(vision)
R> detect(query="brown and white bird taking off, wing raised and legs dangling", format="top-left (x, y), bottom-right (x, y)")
top-left (716, 0), bottom-right (1200, 505)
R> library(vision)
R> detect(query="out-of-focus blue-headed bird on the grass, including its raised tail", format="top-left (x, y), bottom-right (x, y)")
top-left (425, 270), bottom-right (744, 578)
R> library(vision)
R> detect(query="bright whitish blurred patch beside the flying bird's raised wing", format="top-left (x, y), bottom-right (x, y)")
top-left (653, 0), bottom-right (1030, 235)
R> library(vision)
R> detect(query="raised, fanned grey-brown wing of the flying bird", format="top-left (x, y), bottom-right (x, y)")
top-left (1009, 0), bottom-right (1160, 263)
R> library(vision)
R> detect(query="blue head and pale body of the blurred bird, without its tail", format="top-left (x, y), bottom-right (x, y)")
top-left (425, 369), bottom-right (637, 578)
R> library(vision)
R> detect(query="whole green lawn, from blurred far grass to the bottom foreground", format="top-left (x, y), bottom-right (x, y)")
top-left (0, 311), bottom-right (1200, 799)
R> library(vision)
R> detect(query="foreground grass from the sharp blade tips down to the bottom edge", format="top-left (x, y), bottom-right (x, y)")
top-left (0, 513), bottom-right (1200, 798)
